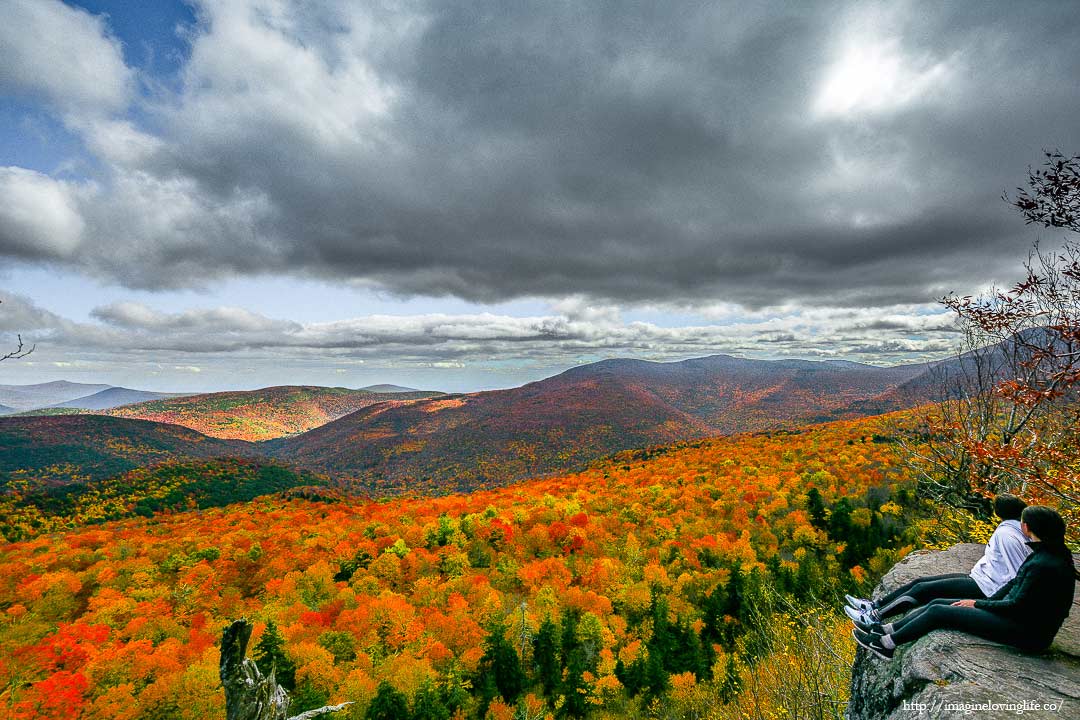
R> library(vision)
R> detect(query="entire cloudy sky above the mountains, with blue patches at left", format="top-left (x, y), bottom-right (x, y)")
top-left (0, 0), bottom-right (1080, 391)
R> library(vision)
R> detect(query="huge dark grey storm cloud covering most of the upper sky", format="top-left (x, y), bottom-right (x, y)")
top-left (0, 1), bottom-right (1080, 306)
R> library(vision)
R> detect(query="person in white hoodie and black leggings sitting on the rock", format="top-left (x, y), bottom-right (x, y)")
top-left (843, 493), bottom-right (1031, 629)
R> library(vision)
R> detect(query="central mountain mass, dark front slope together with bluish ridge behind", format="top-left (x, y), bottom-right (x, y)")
top-left (267, 355), bottom-right (927, 491)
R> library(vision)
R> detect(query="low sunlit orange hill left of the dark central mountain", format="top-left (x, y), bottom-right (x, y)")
top-left (99, 385), bottom-right (440, 440)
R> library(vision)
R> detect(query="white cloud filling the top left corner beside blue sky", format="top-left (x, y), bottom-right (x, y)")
top-left (0, 0), bottom-right (134, 113)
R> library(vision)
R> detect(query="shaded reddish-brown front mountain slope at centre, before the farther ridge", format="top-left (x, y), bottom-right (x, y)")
top-left (267, 378), bottom-right (712, 490)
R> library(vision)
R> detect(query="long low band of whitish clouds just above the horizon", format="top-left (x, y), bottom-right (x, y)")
top-left (0, 296), bottom-right (955, 372)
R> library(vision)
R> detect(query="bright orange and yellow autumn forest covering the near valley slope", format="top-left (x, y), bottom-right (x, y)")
top-left (0, 410), bottom-right (916, 719)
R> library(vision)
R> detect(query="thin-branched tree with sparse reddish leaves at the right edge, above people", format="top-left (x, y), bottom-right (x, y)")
top-left (908, 152), bottom-right (1080, 535)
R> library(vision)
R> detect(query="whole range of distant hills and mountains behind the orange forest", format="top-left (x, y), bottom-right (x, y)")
top-left (0, 355), bottom-right (934, 492)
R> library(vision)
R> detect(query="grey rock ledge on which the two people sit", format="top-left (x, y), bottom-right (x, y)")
top-left (847, 544), bottom-right (1080, 720)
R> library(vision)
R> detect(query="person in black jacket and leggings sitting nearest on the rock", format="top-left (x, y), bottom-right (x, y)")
top-left (852, 505), bottom-right (1076, 660)
